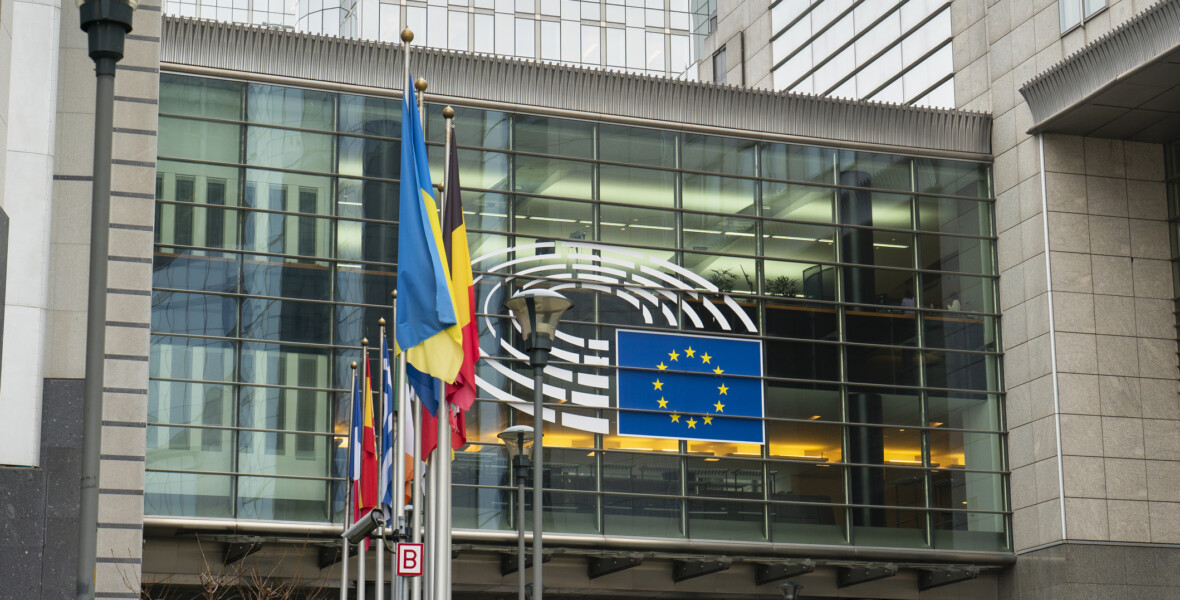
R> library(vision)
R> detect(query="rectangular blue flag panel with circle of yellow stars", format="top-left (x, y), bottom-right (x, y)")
top-left (615, 330), bottom-right (765, 444)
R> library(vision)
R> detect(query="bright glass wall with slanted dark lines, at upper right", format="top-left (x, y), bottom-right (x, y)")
top-left (769, 0), bottom-right (955, 107)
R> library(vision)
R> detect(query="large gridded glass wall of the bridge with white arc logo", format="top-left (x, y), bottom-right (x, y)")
top-left (152, 74), bottom-right (1010, 552)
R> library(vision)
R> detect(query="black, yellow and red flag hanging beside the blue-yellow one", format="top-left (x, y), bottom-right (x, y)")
top-left (443, 128), bottom-right (479, 418)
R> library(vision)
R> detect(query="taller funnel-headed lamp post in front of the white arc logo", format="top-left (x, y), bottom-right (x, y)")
top-left (504, 289), bottom-right (573, 600)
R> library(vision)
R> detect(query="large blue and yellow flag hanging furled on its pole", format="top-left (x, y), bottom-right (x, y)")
top-left (396, 77), bottom-right (464, 383)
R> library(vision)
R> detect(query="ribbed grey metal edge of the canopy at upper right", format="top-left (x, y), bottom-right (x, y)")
top-left (1021, 0), bottom-right (1180, 132)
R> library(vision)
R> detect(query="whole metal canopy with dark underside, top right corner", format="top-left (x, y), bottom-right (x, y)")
top-left (1021, 0), bottom-right (1180, 143)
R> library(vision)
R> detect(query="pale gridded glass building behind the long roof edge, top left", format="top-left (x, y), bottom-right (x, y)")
top-left (164, 0), bottom-right (707, 79)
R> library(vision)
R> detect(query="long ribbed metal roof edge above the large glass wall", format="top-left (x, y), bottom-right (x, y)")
top-left (154, 17), bottom-right (991, 155)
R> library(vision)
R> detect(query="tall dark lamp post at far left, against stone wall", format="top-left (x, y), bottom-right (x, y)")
top-left (76, 0), bottom-right (139, 600)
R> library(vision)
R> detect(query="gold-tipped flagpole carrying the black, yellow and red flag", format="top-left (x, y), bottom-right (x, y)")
top-left (434, 106), bottom-right (458, 600)
